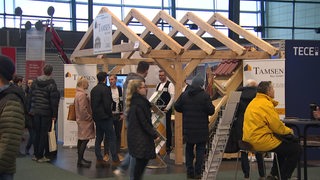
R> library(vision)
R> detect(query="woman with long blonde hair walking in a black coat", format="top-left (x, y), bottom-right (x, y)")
top-left (126, 80), bottom-right (158, 179)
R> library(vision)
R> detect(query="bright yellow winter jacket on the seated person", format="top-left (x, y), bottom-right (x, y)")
top-left (242, 93), bottom-right (293, 151)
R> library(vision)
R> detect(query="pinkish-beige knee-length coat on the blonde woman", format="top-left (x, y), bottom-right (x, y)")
top-left (74, 88), bottom-right (95, 140)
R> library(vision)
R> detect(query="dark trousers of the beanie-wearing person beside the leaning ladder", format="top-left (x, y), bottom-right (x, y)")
top-left (185, 142), bottom-right (206, 175)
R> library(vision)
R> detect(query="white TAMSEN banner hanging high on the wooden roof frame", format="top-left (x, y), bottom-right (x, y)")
top-left (93, 13), bottom-right (112, 54)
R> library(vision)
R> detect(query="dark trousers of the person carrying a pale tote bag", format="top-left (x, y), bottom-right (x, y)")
top-left (33, 115), bottom-right (52, 159)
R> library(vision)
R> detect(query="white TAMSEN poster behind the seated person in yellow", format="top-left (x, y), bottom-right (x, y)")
top-left (243, 59), bottom-right (285, 119)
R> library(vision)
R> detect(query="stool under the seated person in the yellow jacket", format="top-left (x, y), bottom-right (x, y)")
top-left (235, 140), bottom-right (281, 180)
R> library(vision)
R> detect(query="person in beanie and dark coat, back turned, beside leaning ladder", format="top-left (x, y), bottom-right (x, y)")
top-left (174, 75), bottom-right (215, 179)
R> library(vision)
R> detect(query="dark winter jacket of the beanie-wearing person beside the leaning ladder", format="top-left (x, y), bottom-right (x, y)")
top-left (174, 86), bottom-right (215, 143)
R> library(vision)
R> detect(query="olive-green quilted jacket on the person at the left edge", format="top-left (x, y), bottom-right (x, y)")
top-left (0, 85), bottom-right (25, 174)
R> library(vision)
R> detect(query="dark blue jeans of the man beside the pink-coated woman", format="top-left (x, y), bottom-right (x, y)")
top-left (94, 118), bottom-right (119, 161)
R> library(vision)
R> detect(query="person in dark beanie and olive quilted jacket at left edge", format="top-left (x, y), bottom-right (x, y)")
top-left (0, 55), bottom-right (25, 179)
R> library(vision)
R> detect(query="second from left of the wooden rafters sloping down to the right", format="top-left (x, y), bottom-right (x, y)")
top-left (130, 9), bottom-right (184, 54)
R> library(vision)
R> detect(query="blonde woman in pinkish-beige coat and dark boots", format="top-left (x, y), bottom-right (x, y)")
top-left (74, 77), bottom-right (95, 168)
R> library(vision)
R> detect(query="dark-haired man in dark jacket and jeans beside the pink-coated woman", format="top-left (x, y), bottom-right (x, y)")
top-left (90, 72), bottom-right (120, 168)
